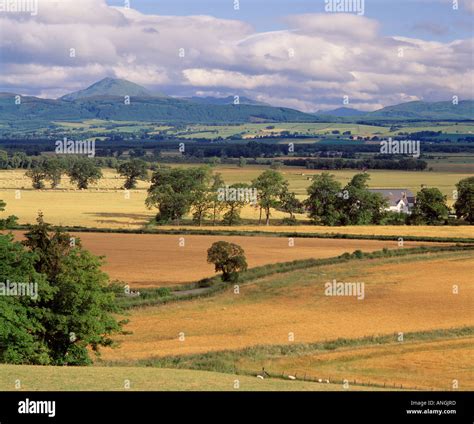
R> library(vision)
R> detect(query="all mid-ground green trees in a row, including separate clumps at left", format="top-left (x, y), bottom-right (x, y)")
top-left (2, 156), bottom-right (474, 226)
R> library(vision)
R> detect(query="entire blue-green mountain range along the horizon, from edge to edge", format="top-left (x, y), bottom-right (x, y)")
top-left (0, 78), bottom-right (474, 124)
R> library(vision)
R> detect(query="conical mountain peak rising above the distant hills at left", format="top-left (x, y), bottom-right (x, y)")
top-left (61, 77), bottom-right (154, 101)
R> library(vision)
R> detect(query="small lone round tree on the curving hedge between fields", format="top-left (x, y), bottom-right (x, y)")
top-left (207, 241), bottom-right (247, 282)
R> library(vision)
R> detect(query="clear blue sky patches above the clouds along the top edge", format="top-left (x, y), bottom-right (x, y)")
top-left (108, 0), bottom-right (474, 41)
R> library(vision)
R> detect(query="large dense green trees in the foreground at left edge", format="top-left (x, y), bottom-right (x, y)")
top-left (0, 215), bottom-right (124, 365)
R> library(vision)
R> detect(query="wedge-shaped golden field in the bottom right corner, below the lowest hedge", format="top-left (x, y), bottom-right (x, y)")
top-left (238, 337), bottom-right (474, 391)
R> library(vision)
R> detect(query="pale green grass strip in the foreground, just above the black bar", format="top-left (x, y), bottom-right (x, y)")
top-left (0, 365), bottom-right (369, 391)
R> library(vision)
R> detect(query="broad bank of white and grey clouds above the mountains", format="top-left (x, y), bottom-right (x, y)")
top-left (0, 0), bottom-right (474, 111)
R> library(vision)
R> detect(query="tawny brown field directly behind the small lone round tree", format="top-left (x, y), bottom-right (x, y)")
top-left (8, 231), bottom-right (436, 287)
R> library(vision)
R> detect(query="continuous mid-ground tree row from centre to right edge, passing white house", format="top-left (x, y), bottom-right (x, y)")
top-left (146, 167), bottom-right (474, 226)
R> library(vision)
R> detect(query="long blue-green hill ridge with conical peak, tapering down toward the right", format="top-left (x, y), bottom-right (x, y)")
top-left (0, 78), bottom-right (318, 126)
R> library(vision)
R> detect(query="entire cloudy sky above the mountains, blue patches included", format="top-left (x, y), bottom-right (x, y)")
top-left (0, 0), bottom-right (474, 112)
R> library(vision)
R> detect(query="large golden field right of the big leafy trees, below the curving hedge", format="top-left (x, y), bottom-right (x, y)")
top-left (104, 252), bottom-right (474, 360)
